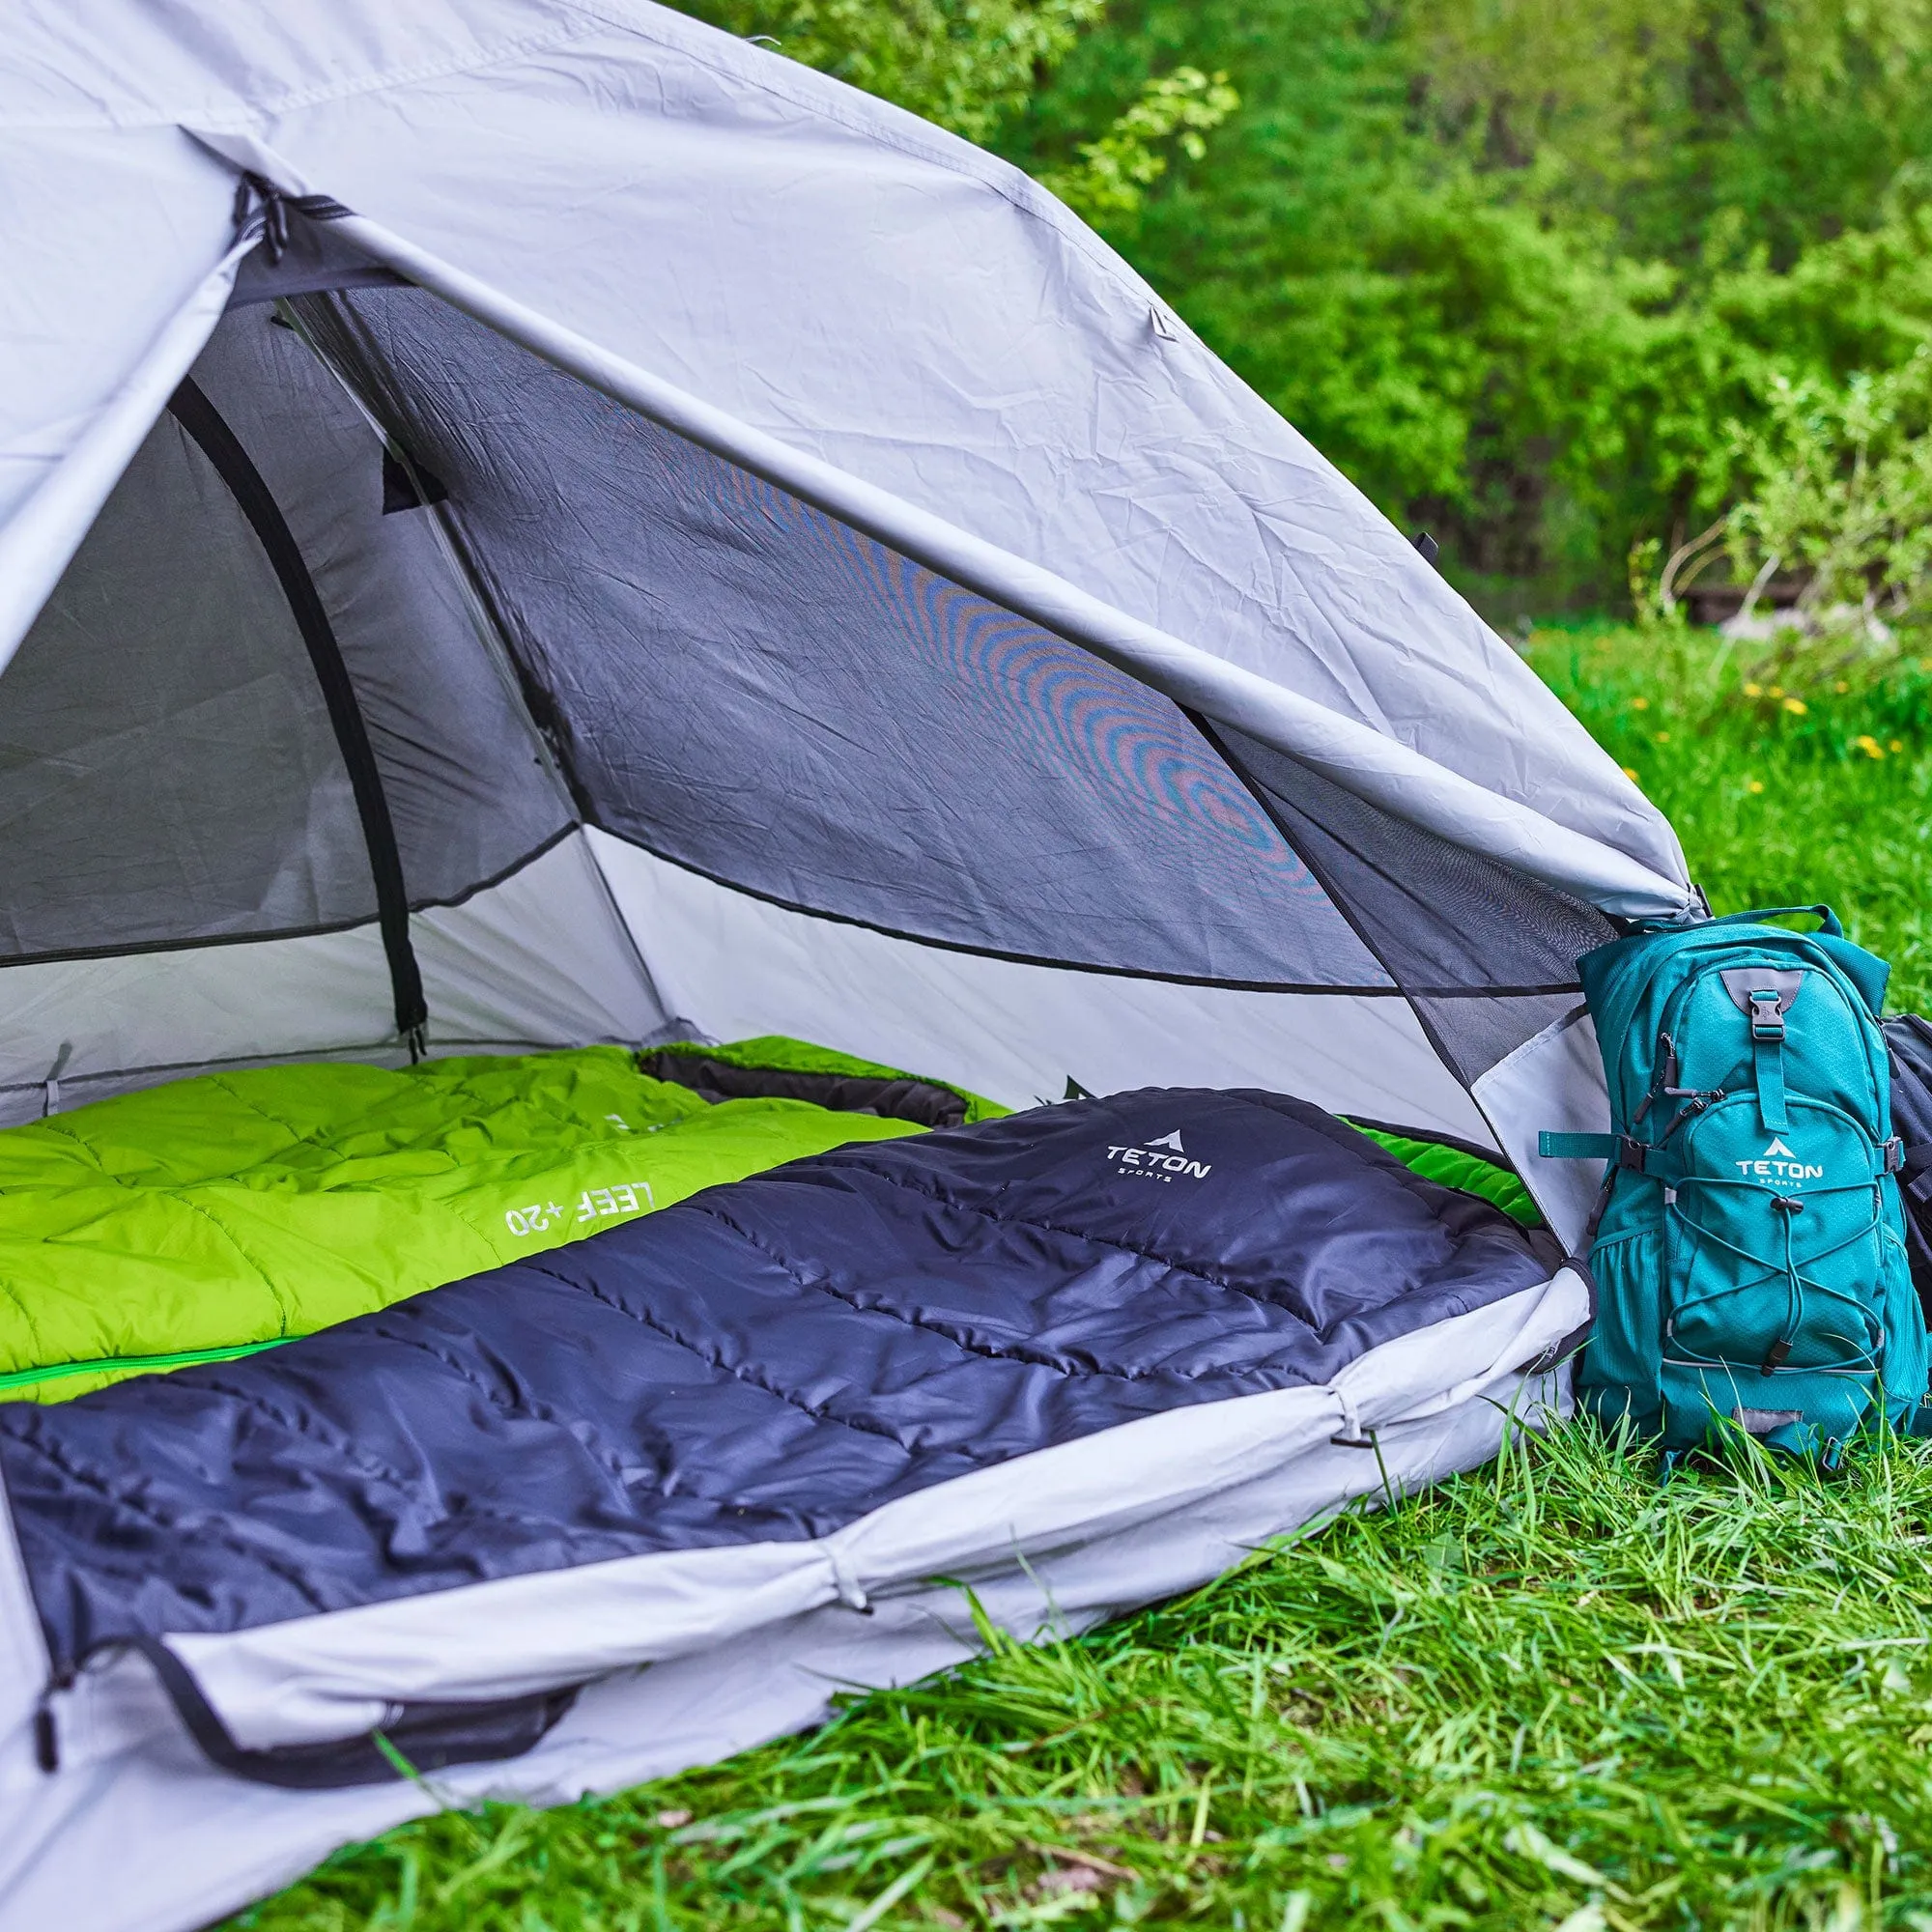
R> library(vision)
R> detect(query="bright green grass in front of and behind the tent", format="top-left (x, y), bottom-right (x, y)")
top-left (236, 630), bottom-right (1932, 1932)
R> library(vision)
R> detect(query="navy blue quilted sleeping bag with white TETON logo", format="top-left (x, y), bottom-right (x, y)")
top-left (0, 1090), bottom-right (1549, 1785)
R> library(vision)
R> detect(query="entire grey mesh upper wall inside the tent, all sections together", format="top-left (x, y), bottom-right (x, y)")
top-left (0, 267), bottom-right (1611, 1080)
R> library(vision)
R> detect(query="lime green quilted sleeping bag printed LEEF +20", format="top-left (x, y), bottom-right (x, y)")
top-left (0, 1041), bottom-right (951, 1401)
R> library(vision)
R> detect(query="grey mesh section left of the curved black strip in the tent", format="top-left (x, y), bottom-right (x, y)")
top-left (0, 417), bottom-right (375, 958)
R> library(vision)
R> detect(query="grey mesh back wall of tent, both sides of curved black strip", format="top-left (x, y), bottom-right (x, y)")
top-left (0, 307), bottom-right (574, 960)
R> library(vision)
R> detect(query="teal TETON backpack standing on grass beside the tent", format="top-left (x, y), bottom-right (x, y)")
top-left (1540, 906), bottom-right (1926, 1468)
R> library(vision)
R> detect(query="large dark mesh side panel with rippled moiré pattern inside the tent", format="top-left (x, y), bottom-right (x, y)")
top-left (296, 290), bottom-right (1389, 991)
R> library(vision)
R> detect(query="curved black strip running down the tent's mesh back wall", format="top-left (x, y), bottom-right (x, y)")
top-left (168, 377), bottom-right (429, 1059)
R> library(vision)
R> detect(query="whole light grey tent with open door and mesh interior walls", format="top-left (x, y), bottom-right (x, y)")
top-left (0, 0), bottom-right (1696, 1932)
